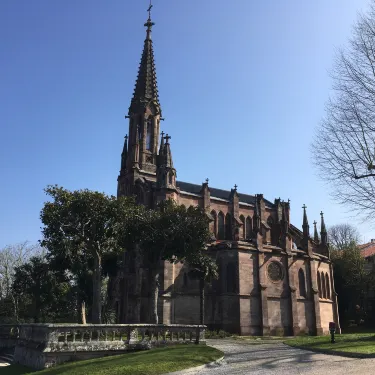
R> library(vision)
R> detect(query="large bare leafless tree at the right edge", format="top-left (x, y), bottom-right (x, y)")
top-left (312, 0), bottom-right (375, 219)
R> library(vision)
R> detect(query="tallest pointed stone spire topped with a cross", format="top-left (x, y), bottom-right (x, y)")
top-left (129, 1), bottom-right (161, 115)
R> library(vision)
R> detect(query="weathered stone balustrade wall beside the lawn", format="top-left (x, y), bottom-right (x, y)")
top-left (0, 324), bottom-right (206, 370)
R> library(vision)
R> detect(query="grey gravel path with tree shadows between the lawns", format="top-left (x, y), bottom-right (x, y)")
top-left (181, 340), bottom-right (375, 375)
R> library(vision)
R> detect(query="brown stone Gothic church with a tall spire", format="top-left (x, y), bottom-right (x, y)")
top-left (113, 7), bottom-right (340, 335)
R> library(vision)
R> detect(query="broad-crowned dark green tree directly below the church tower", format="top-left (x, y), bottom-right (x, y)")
top-left (122, 200), bottom-right (210, 324)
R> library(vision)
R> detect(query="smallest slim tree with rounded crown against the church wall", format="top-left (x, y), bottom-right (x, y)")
top-left (188, 253), bottom-right (219, 325)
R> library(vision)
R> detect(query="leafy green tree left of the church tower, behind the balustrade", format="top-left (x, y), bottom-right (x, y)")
top-left (41, 186), bottom-right (126, 324)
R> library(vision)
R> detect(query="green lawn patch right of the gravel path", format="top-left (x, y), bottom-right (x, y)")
top-left (285, 333), bottom-right (375, 357)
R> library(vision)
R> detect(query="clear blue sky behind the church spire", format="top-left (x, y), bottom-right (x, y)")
top-left (0, 0), bottom-right (375, 247)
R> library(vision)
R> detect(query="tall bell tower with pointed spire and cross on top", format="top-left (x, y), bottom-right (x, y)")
top-left (117, 0), bottom-right (162, 200)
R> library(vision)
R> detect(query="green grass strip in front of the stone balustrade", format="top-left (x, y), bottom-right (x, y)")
top-left (1, 345), bottom-right (223, 375)
